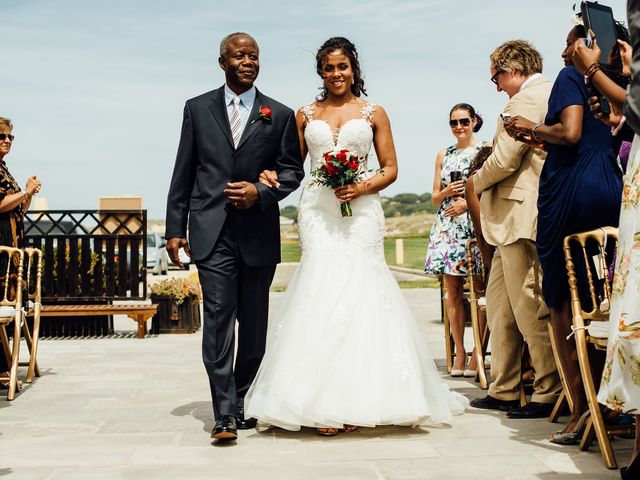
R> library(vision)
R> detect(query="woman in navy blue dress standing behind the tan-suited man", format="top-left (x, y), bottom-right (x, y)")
top-left (509, 21), bottom-right (622, 444)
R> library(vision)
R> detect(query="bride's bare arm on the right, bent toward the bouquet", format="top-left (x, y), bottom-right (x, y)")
top-left (336, 106), bottom-right (398, 203)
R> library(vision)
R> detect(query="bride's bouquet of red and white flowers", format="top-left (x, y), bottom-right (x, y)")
top-left (311, 148), bottom-right (367, 217)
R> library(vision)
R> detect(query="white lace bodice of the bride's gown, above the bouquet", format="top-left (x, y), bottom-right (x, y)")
top-left (300, 103), bottom-right (376, 170)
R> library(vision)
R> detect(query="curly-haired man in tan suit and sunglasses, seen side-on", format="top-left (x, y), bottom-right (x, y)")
top-left (470, 40), bottom-right (561, 418)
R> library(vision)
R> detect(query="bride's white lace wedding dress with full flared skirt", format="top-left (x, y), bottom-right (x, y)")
top-left (245, 104), bottom-right (467, 430)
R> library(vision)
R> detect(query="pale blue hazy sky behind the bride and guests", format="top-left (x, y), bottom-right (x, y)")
top-left (0, 0), bottom-right (626, 219)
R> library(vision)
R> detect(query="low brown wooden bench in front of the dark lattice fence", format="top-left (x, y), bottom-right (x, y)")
top-left (28, 304), bottom-right (158, 338)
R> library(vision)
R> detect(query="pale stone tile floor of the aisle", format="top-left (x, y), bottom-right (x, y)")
top-left (0, 289), bottom-right (632, 480)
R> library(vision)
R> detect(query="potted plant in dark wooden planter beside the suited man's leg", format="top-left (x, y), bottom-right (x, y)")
top-left (149, 273), bottom-right (202, 333)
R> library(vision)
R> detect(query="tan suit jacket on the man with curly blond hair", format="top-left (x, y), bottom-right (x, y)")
top-left (472, 76), bottom-right (551, 246)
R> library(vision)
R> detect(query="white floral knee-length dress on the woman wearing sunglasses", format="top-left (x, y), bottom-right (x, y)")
top-left (424, 143), bottom-right (482, 276)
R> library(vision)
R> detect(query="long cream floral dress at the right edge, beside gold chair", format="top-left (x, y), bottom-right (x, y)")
top-left (598, 135), bottom-right (640, 413)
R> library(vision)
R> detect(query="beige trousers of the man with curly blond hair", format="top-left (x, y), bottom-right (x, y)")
top-left (487, 239), bottom-right (562, 403)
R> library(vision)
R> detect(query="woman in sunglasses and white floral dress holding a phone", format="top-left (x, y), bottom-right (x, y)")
top-left (424, 103), bottom-right (482, 377)
